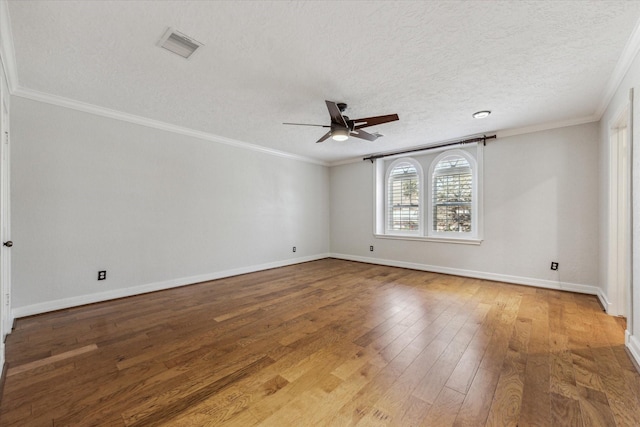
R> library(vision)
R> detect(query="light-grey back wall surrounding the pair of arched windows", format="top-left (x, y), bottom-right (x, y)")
top-left (330, 123), bottom-right (599, 294)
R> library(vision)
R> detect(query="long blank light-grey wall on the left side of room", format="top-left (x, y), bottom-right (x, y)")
top-left (11, 97), bottom-right (329, 317)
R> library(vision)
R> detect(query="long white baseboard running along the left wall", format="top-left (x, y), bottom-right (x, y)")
top-left (11, 254), bottom-right (329, 319)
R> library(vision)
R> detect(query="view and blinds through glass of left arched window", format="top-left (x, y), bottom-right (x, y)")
top-left (387, 162), bottom-right (420, 231)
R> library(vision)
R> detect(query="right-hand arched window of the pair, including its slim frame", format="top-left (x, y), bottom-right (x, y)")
top-left (428, 150), bottom-right (477, 235)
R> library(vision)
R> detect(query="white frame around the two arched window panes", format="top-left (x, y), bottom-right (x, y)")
top-left (373, 144), bottom-right (484, 245)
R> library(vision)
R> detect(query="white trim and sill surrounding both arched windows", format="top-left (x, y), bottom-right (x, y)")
top-left (373, 144), bottom-right (484, 245)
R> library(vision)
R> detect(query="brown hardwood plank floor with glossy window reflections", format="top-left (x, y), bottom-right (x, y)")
top-left (0, 259), bottom-right (640, 427)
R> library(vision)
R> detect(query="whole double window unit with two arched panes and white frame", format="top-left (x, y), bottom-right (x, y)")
top-left (373, 145), bottom-right (484, 245)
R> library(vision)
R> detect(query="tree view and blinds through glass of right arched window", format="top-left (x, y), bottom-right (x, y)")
top-left (432, 156), bottom-right (473, 233)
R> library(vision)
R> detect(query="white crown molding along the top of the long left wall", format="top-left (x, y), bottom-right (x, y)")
top-left (12, 87), bottom-right (328, 166)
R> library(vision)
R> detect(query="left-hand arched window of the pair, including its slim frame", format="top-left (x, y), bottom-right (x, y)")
top-left (385, 158), bottom-right (423, 234)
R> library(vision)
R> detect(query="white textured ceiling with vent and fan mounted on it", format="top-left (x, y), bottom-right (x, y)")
top-left (8, 0), bottom-right (640, 162)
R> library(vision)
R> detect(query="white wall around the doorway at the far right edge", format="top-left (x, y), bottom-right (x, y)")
top-left (599, 47), bottom-right (640, 364)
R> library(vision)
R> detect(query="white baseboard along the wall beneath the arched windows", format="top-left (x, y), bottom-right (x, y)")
top-left (331, 253), bottom-right (606, 298)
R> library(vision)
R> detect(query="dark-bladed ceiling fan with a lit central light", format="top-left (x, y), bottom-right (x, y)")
top-left (283, 101), bottom-right (399, 142)
